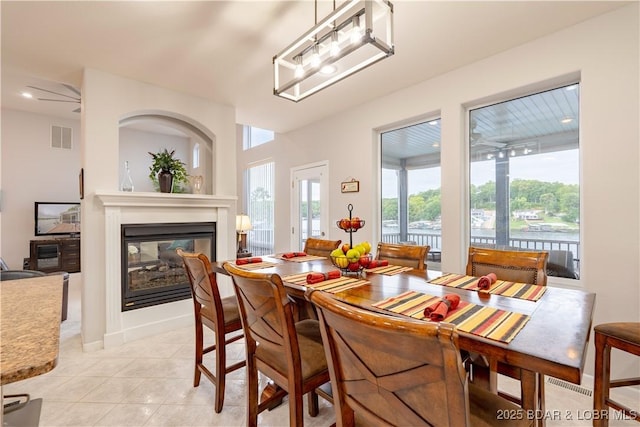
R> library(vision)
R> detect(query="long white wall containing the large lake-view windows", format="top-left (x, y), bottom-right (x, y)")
top-left (238, 3), bottom-right (640, 376)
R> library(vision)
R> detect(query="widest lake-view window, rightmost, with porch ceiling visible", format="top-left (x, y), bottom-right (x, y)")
top-left (469, 83), bottom-right (580, 278)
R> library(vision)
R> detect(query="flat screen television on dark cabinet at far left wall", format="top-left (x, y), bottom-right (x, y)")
top-left (34, 202), bottom-right (80, 236)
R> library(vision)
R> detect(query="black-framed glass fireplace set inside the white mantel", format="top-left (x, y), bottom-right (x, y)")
top-left (120, 222), bottom-right (216, 311)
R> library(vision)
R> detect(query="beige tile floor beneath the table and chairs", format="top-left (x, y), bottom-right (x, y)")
top-left (3, 275), bottom-right (640, 427)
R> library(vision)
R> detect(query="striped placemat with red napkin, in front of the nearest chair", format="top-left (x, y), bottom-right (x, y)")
top-left (373, 291), bottom-right (529, 344)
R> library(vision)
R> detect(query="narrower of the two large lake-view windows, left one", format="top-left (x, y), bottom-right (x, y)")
top-left (380, 118), bottom-right (441, 269)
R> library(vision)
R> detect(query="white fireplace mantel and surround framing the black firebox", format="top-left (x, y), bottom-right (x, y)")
top-left (95, 191), bottom-right (237, 348)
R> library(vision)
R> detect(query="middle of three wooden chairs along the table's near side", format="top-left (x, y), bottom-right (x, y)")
top-left (223, 262), bottom-right (329, 427)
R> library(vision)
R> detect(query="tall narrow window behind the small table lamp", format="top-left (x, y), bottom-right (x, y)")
top-left (244, 162), bottom-right (275, 256)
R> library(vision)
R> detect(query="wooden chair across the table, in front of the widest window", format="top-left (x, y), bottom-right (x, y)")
top-left (466, 246), bottom-right (549, 410)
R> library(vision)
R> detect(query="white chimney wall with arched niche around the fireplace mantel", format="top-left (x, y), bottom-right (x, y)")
top-left (81, 69), bottom-right (236, 348)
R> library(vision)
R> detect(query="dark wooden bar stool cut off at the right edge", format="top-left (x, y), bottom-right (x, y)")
top-left (593, 322), bottom-right (640, 427)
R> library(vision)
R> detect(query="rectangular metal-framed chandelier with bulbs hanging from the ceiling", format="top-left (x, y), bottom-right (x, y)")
top-left (273, 0), bottom-right (395, 102)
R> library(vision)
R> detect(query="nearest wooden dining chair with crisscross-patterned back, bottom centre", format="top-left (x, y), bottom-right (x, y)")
top-left (306, 289), bottom-right (532, 427)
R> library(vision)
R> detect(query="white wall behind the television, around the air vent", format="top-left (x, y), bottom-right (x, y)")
top-left (0, 109), bottom-right (80, 270)
